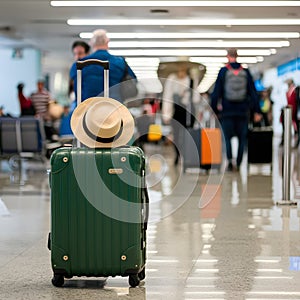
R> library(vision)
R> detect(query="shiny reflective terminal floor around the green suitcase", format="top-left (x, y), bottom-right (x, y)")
top-left (0, 138), bottom-right (300, 300)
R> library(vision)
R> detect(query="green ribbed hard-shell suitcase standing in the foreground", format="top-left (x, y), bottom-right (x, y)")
top-left (48, 146), bottom-right (149, 287)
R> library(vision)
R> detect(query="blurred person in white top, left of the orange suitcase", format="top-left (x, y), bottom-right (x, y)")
top-left (162, 64), bottom-right (200, 165)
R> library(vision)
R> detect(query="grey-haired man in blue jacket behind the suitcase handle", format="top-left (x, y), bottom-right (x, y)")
top-left (70, 29), bottom-right (136, 101)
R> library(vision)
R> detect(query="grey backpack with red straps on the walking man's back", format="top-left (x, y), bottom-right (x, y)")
top-left (224, 64), bottom-right (248, 102)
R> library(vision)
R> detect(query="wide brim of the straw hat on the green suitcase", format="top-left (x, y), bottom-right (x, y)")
top-left (71, 97), bottom-right (134, 148)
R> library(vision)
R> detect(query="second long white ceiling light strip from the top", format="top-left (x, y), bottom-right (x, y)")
top-left (67, 18), bottom-right (300, 26)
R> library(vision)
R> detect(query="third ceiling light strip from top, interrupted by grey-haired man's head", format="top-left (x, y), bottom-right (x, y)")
top-left (79, 31), bottom-right (300, 39)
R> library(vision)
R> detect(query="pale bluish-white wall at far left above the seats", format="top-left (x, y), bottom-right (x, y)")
top-left (0, 49), bottom-right (41, 116)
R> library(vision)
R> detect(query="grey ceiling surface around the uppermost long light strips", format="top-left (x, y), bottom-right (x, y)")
top-left (0, 0), bottom-right (300, 75)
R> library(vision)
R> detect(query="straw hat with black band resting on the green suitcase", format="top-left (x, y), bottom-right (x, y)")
top-left (71, 97), bottom-right (134, 148)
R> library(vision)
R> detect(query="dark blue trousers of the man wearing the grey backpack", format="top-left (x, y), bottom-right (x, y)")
top-left (221, 116), bottom-right (248, 166)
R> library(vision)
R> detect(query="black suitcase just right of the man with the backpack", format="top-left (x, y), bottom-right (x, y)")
top-left (248, 127), bottom-right (273, 164)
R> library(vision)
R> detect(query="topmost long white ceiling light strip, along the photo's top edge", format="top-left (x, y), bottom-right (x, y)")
top-left (50, 1), bottom-right (300, 7)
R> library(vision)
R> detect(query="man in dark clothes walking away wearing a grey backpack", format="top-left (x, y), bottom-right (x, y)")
top-left (211, 48), bottom-right (262, 171)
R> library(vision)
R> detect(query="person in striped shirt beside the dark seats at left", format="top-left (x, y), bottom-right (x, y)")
top-left (30, 79), bottom-right (57, 141)
